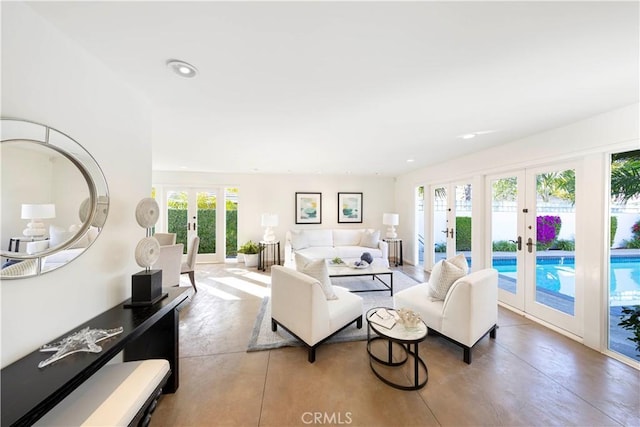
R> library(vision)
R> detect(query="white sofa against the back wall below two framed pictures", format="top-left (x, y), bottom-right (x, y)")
top-left (284, 228), bottom-right (389, 268)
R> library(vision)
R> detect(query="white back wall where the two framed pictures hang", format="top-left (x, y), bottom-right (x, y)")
top-left (153, 171), bottom-right (402, 258)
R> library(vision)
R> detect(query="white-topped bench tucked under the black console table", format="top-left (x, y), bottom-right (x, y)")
top-left (35, 359), bottom-right (171, 426)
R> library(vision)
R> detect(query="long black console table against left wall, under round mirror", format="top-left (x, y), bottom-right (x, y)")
top-left (0, 288), bottom-right (187, 426)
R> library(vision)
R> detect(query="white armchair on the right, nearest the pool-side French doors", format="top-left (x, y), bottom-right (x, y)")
top-left (393, 268), bottom-right (498, 363)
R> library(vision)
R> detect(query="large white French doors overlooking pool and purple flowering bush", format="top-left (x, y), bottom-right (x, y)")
top-left (487, 163), bottom-right (582, 336)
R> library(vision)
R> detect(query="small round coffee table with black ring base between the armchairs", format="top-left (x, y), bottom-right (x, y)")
top-left (366, 307), bottom-right (429, 390)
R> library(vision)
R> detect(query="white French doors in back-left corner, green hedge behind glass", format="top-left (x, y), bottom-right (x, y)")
top-left (165, 188), bottom-right (225, 262)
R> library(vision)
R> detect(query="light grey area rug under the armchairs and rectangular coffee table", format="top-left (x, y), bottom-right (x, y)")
top-left (247, 271), bottom-right (419, 351)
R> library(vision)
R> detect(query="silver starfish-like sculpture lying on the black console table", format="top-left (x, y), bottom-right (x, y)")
top-left (38, 326), bottom-right (123, 368)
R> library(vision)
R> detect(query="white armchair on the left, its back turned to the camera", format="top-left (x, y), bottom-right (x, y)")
top-left (271, 265), bottom-right (363, 363)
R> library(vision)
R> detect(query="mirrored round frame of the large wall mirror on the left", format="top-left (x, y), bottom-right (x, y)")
top-left (0, 117), bottom-right (109, 280)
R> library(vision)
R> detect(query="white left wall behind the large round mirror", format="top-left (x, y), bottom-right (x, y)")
top-left (0, 2), bottom-right (151, 366)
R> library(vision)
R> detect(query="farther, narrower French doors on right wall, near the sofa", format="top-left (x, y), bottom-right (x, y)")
top-left (430, 182), bottom-right (472, 266)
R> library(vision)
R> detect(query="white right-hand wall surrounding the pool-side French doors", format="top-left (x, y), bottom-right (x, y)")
top-left (395, 104), bottom-right (640, 350)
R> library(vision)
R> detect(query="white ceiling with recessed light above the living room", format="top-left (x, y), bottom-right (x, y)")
top-left (29, 1), bottom-right (640, 176)
